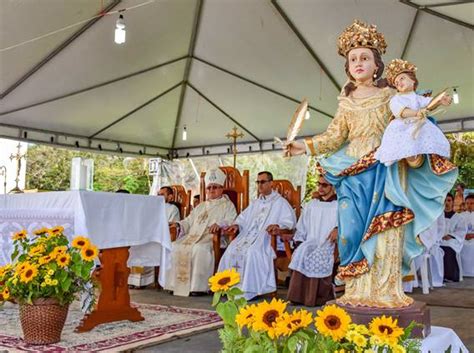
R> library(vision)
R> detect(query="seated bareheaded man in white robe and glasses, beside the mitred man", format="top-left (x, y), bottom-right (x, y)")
top-left (219, 172), bottom-right (296, 300)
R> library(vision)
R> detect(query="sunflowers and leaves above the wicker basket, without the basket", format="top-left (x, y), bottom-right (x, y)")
top-left (0, 227), bottom-right (98, 305)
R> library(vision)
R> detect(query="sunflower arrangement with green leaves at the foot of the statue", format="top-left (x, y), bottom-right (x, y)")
top-left (209, 269), bottom-right (420, 353)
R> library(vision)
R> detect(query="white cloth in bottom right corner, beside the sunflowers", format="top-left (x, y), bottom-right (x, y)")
top-left (421, 326), bottom-right (469, 353)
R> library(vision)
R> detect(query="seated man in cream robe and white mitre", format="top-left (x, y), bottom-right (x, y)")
top-left (165, 169), bottom-right (237, 296)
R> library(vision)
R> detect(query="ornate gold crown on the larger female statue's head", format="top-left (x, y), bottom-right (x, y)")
top-left (337, 20), bottom-right (387, 56)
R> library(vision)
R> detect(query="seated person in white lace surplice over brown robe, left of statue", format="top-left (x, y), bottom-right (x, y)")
top-left (288, 176), bottom-right (337, 306)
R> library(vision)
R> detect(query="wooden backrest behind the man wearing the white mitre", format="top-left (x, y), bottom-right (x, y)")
top-left (201, 166), bottom-right (249, 214)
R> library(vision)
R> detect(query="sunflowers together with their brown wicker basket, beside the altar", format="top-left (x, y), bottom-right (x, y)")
top-left (0, 227), bottom-right (98, 344)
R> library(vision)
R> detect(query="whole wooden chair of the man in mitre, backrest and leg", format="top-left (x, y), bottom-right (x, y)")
top-left (201, 166), bottom-right (249, 270)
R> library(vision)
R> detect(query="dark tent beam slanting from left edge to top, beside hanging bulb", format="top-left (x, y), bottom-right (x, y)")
top-left (0, 0), bottom-right (122, 99)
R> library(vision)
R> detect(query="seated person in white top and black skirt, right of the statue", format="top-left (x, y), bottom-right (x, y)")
top-left (440, 194), bottom-right (467, 282)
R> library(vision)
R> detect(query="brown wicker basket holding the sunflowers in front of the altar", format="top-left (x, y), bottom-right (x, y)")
top-left (20, 298), bottom-right (69, 344)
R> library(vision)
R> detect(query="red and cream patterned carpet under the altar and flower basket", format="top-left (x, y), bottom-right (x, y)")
top-left (0, 303), bottom-right (222, 352)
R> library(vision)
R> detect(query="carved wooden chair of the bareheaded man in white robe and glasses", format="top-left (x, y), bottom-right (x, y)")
top-left (271, 179), bottom-right (301, 282)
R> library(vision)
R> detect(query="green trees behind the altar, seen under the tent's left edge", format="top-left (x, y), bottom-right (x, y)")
top-left (26, 145), bottom-right (149, 194)
